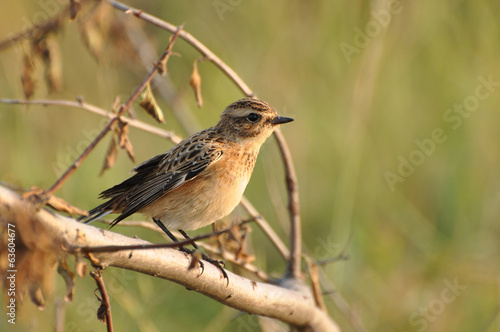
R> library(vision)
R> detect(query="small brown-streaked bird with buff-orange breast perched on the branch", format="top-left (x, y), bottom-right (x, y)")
top-left (80, 98), bottom-right (293, 239)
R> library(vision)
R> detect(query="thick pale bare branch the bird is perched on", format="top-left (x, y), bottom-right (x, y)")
top-left (0, 186), bottom-right (339, 331)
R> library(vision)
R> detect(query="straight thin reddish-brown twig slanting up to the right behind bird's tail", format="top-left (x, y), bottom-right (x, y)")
top-left (46, 27), bottom-right (182, 197)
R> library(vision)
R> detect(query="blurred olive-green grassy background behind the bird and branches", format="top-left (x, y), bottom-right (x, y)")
top-left (0, 0), bottom-right (500, 332)
